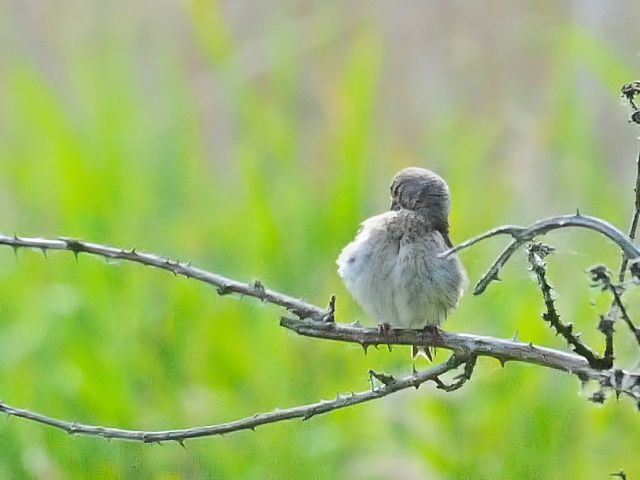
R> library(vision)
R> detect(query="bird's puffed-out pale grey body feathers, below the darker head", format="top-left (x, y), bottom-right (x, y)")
top-left (337, 212), bottom-right (464, 328)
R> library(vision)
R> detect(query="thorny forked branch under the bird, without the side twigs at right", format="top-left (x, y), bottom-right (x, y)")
top-left (0, 229), bottom-right (640, 442)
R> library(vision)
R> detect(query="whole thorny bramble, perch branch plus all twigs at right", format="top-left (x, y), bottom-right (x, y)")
top-left (0, 82), bottom-right (640, 442)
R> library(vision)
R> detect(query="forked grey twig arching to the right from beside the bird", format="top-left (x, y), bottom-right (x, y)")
top-left (440, 213), bottom-right (640, 295)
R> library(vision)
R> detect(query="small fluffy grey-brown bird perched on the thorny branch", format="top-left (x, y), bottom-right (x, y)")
top-left (337, 167), bottom-right (467, 358)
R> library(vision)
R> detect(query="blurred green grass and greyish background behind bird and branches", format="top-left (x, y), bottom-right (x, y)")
top-left (0, 0), bottom-right (640, 480)
